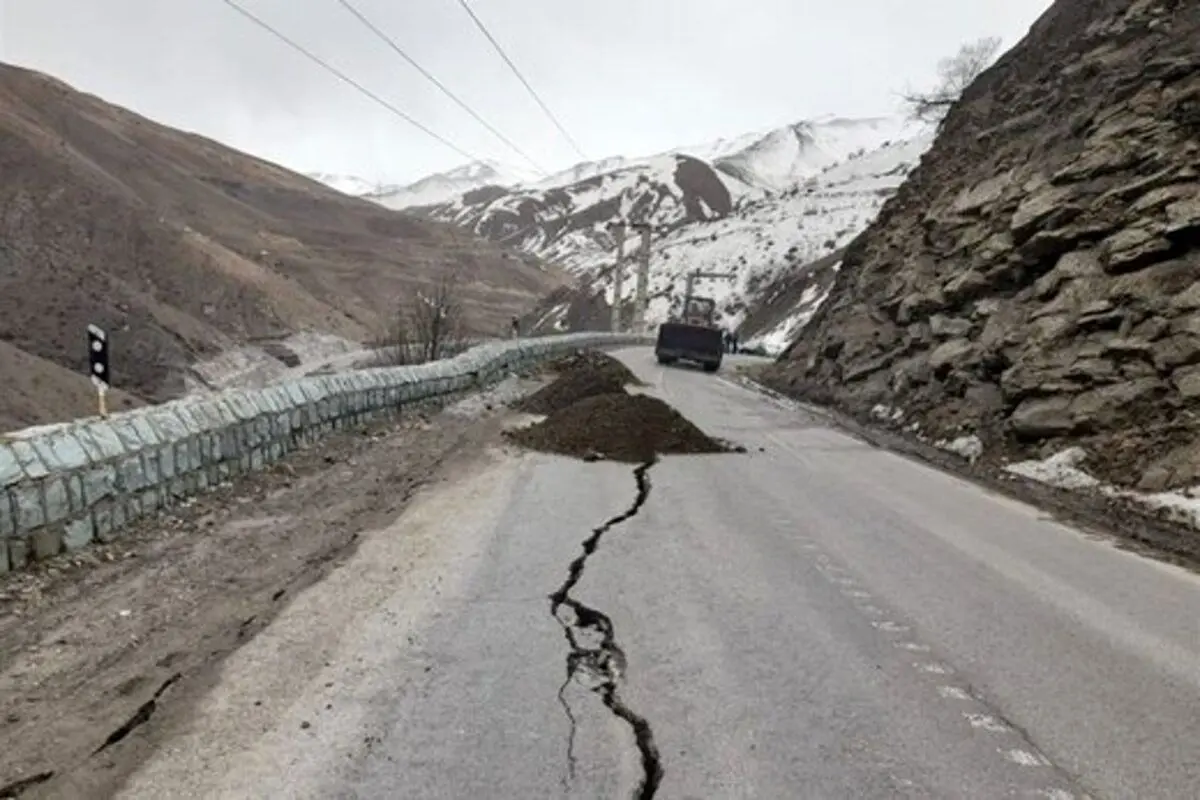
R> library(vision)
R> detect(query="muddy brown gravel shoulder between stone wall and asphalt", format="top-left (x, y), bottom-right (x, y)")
top-left (0, 379), bottom-right (539, 798)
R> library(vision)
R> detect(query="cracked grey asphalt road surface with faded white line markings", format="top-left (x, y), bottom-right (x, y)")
top-left (117, 350), bottom-right (1200, 800)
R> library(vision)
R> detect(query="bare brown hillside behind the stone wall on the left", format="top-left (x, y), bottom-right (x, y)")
top-left (0, 65), bottom-right (563, 423)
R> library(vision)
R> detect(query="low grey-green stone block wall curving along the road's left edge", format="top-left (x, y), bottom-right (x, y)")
top-left (0, 333), bottom-right (649, 573)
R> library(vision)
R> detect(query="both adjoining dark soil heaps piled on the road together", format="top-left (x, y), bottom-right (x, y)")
top-left (506, 353), bottom-right (730, 463)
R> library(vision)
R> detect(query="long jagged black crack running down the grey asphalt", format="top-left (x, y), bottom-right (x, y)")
top-left (550, 461), bottom-right (664, 800)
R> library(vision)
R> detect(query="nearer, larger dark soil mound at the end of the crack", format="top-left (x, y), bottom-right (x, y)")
top-left (508, 391), bottom-right (728, 463)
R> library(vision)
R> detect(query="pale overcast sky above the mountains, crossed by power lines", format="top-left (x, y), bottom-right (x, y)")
top-left (0, 0), bottom-right (1050, 181)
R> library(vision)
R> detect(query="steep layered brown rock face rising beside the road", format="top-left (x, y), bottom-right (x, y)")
top-left (770, 0), bottom-right (1200, 491)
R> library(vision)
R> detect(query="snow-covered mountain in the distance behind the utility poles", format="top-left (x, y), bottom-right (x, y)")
top-left (324, 116), bottom-right (932, 349)
